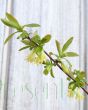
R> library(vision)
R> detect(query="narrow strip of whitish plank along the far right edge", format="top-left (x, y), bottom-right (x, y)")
top-left (83, 0), bottom-right (88, 110)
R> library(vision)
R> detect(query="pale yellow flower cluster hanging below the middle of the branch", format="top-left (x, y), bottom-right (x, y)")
top-left (26, 51), bottom-right (46, 64)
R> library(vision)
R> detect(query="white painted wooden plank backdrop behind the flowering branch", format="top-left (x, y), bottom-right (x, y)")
top-left (0, 0), bottom-right (88, 110)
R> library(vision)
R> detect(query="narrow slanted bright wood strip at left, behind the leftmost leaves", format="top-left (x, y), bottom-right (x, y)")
top-left (0, 0), bottom-right (12, 110)
